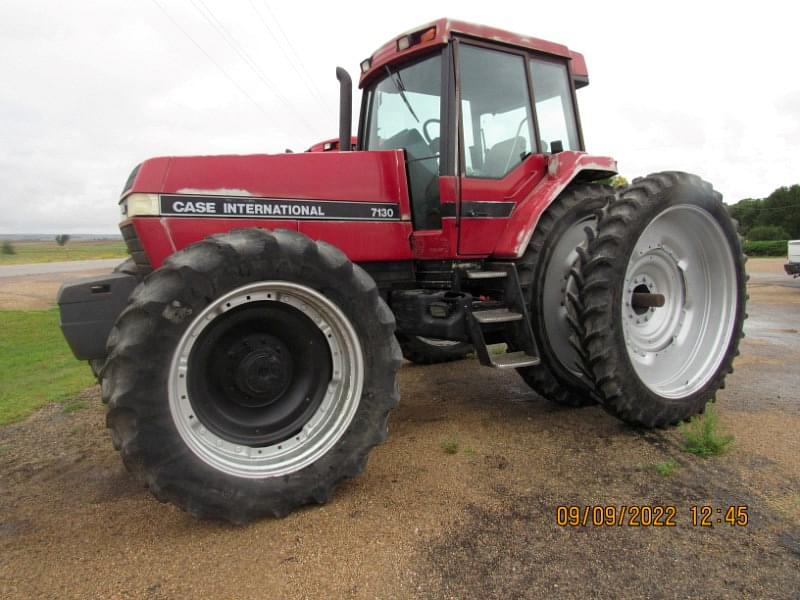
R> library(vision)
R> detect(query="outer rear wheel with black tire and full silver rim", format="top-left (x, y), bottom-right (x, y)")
top-left (575, 172), bottom-right (746, 427)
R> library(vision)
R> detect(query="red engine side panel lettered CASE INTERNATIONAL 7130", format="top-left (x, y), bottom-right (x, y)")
top-left (127, 150), bottom-right (412, 268)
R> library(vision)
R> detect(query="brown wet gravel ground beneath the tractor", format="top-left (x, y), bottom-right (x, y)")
top-left (0, 260), bottom-right (800, 599)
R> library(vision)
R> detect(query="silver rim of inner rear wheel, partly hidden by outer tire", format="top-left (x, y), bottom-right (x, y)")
top-left (542, 216), bottom-right (597, 379)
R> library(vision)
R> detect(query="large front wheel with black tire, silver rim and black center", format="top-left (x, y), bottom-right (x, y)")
top-left (102, 229), bottom-right (400, 523)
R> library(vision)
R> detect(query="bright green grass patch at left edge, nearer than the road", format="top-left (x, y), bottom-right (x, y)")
top-left (0, 309), bottom-right (94, 425)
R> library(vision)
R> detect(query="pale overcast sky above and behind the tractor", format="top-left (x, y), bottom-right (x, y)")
top-left (0, 0), bottom-right (800, 233)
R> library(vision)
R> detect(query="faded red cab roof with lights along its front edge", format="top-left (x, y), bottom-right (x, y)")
top-left (358, 18), bottom-right (589, 88)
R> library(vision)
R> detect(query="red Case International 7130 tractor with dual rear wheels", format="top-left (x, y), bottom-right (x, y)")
top-left (59, 19), bottom-right (746, 522)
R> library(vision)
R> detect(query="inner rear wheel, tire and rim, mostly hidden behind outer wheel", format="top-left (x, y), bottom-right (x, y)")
top-left (517, 183), bottom-right (614, 407)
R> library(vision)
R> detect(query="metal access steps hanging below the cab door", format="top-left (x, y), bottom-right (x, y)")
top-left (462, 262), bottom-right (540, 369)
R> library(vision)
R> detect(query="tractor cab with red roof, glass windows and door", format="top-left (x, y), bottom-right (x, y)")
top-left (358, 20), bottom-right (588, 248)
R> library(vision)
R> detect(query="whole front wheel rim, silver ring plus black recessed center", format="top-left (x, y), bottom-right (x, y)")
top-left (168, 281), bottom-right (364, 478)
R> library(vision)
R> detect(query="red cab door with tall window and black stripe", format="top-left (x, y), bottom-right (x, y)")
top-left (456, 40), bottom-right (545, 256)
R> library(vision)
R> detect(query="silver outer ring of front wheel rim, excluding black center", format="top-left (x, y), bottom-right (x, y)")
top-left (168, 281), bottom-right (364, 479)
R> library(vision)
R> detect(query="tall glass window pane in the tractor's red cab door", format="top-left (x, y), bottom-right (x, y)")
top-left (459, 44), bottom-right (534, 179)
